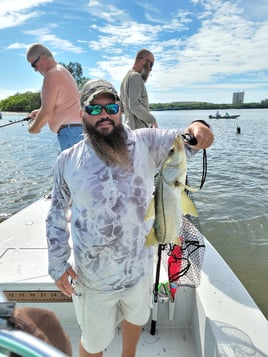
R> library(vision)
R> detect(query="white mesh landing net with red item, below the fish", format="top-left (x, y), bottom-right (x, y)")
top-left (162, 217), bottom-right (205, 287)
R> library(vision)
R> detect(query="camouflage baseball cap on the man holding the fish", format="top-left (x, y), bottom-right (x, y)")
top-left (81, 79), bottom-right (120, 106)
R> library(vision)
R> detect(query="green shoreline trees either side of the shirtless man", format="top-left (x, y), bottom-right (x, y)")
top-left (0, 62), bottom-right (89, 113)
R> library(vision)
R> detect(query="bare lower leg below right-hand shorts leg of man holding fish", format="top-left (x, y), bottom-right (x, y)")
top-left (121, 320), bottom-right (142, 357)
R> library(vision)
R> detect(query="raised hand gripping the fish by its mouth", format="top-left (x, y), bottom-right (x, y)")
top-left (184, 121), bottom-right (214, 150)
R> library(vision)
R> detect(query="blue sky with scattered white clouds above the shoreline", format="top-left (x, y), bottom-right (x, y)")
top-left (0, 0), bottom-right (268, 103)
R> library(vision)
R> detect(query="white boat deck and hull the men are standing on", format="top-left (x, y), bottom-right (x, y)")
top-left (0, 199), bottom-right (268, 357)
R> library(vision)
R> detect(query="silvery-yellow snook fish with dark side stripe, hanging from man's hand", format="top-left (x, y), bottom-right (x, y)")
top-left (145, 136), bottom-right (198, 247)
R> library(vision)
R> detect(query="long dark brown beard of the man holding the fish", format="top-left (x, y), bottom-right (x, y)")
top-left (83, 118), bottom-right (129, 168)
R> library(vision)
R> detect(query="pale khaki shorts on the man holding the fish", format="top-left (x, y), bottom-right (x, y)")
top-left (73, 275), bottom-right (152, 353)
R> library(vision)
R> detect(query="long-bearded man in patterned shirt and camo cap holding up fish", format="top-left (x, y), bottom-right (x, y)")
top-left (47, 79), bottom-right (213, 357)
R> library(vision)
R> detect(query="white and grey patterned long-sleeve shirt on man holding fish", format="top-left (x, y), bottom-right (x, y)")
top-left (47, 127), bottom-right (193, 291)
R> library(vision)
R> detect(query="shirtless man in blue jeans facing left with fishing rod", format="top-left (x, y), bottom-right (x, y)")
top-left (26, 43), bottom-right (83, 151)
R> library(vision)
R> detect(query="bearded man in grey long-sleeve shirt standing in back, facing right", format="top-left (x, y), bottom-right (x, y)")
top-left (120, 49), bottom-right (157, 129)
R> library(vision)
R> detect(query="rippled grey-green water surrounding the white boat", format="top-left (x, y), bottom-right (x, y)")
top-left (0, 109), bottom-right (268, 318)
